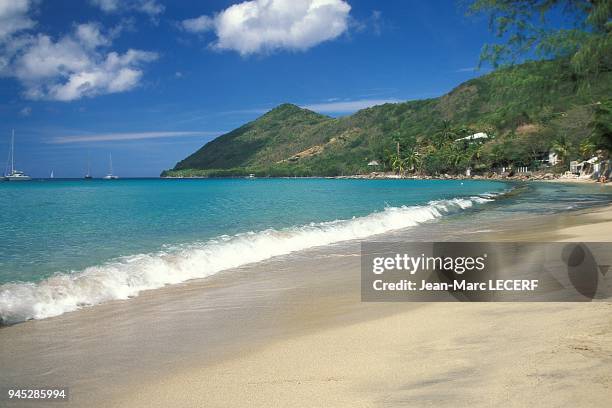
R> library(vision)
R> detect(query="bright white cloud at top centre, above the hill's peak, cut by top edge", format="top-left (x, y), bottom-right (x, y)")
top-left (182, 0), bottom-right (351, 55)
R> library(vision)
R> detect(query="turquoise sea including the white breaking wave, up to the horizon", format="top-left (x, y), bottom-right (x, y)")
top-left (0, 179), bottom-right (611, 323)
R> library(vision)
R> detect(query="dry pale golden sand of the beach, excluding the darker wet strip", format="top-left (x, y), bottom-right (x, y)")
top-left (109, 207), bottom-right (612, 407)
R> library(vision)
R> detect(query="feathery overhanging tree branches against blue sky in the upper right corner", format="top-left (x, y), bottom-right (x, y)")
top-left (469, 0), bottom-right (612, 75)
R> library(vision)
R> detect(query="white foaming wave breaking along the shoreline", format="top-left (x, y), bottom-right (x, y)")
top-left (0, 195), bottom-right (493, 325)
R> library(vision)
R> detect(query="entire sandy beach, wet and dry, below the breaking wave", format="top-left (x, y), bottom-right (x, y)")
top-left (0, 207), bottom-right (612, 407)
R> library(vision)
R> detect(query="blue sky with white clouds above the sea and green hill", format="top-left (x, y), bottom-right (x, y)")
top-left (0, 0), bottom-right (502, 177)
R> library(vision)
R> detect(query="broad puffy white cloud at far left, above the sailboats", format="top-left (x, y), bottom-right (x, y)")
top-left (0, 23), bottom-right (157, 101)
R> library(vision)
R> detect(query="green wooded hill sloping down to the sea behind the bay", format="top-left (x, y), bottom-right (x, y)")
top-left (162, 60), bottom-right (612, 177)
